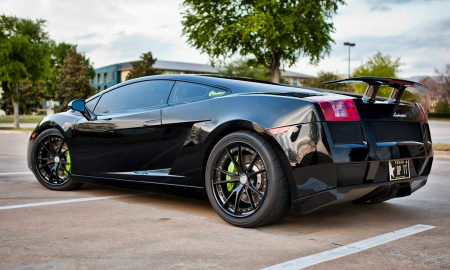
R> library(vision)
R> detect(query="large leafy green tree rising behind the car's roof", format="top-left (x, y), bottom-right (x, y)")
top-left (182, 0), bottom-right (345, 83)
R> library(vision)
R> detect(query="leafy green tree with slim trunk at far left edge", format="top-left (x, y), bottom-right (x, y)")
top-left (0, 15), bottom-right (50, 128)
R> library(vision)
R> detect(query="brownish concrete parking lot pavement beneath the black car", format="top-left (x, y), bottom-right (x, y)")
top-left (0, 131), bottom-right (450, 269)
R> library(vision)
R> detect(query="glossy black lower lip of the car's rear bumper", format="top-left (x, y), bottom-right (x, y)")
top-left (291, 176), bottom-right (428, 214)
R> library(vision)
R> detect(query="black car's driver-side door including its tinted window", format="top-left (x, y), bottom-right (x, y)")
top-left (71, 80), bottom-right (174, 180)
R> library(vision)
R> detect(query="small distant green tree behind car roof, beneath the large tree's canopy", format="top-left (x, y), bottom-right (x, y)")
top-left (219, 59), bottom-right (285, 83)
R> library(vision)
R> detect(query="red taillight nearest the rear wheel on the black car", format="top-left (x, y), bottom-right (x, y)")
top-left (306, 96), bottom-right (361, 121)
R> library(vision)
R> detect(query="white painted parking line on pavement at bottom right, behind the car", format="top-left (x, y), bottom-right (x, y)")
top-left (262, 224), bottom-right (434, 270)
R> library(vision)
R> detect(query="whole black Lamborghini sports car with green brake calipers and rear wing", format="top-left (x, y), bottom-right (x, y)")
top-left (28, 75), bottom-right (433, 227)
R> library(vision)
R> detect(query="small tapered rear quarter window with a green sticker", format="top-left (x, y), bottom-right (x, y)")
top-left (170, 82), bottom-right (228, 103)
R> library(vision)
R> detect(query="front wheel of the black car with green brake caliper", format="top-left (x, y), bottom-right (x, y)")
top-left (31, 129), bottom-right (83, 191)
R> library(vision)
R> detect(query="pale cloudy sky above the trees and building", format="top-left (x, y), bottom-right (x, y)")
top-left (0, 0), bottom-right (450, 78)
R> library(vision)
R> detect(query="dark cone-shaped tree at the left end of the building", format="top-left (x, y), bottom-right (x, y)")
top-left (55, 48), bottom-right (95, 111)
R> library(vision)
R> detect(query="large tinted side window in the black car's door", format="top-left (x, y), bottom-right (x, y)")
top-left (94, 80), bottom-right (174, 114)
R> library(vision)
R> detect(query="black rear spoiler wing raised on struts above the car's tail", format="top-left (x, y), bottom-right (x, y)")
top-left (324, 77), bottom-right (430, 103)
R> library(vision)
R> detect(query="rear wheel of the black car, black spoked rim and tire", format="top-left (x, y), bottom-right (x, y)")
top-left (205, 131), bottom-right (290, 228)
